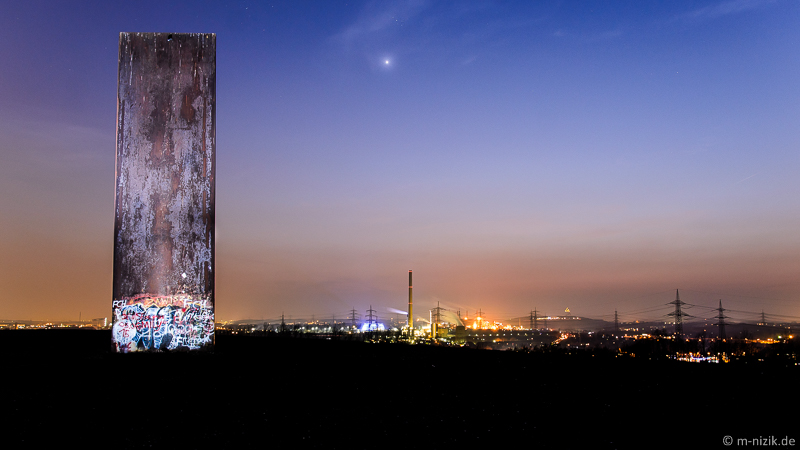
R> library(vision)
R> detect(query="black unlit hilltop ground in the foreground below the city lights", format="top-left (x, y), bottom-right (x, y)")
top-left (0, 330), bottom-right (800, 449)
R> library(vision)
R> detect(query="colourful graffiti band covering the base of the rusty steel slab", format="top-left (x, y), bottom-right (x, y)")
top-left (112, 294), bottom-right (214, 353)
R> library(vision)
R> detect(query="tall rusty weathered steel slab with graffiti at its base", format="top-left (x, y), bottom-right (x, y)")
top-left (112, 33), bottom-right (216, 353)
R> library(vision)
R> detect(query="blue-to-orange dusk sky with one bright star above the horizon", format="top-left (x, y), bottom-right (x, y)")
top-left (0, 0), bottom-right (800, 320)
